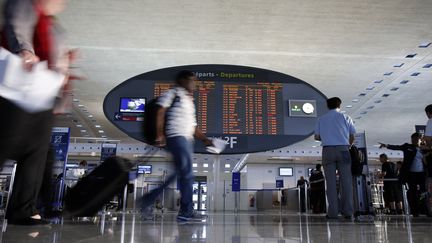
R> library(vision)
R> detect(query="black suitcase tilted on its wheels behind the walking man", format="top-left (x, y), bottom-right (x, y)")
top-left (65, 157), bottom-right (132, 217)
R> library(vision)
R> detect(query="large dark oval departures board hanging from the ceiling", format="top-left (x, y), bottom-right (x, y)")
top-left (103, 65), bottom-right (327, 154)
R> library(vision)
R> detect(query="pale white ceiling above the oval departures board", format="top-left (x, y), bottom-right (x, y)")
top-left (49, 0), bottom-right (432, 149)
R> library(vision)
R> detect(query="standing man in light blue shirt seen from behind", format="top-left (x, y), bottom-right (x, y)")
top-left (315, 97), bottom-right (356, 219)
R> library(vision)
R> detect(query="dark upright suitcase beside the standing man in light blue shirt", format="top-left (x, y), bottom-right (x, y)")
top-left (353, 175), bottom-right (375, 222)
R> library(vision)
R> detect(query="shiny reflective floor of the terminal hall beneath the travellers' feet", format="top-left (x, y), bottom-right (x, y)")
top-left (0, 212), bottom-right (432, 243)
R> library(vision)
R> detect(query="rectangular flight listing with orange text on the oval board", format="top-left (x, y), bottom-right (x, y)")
top-left (153, 81), bottom-right (284, 135)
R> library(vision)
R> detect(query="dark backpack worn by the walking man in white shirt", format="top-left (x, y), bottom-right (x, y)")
top-left (143, 90), bottom-right (180, 145)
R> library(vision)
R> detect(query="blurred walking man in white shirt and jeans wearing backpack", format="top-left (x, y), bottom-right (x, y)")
top-left (143, 71), bottom-right (213, 221)
